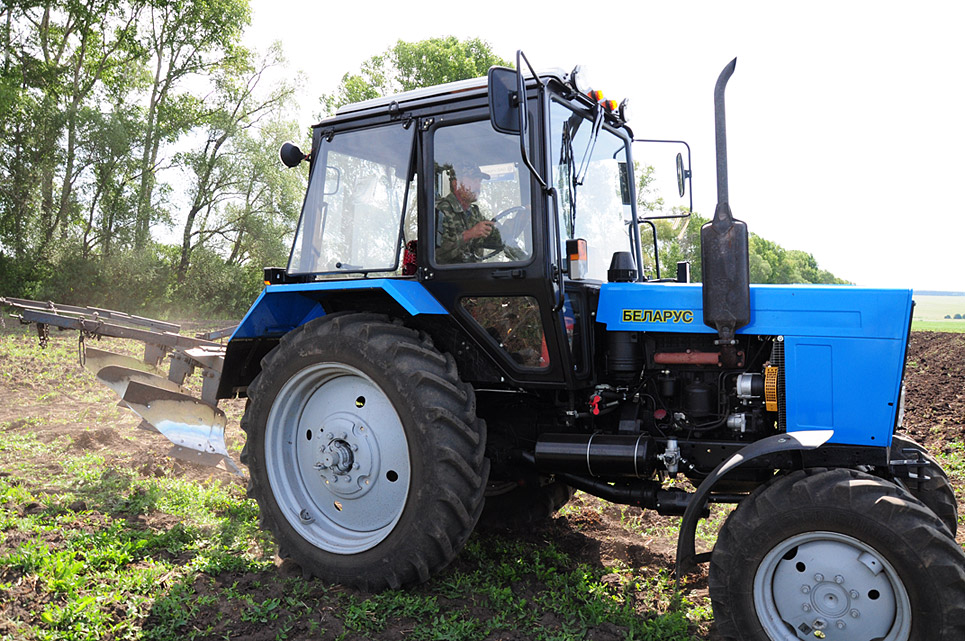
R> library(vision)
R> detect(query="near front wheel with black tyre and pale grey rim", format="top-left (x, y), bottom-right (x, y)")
top-left (709, 469), bottom-right (965, 641)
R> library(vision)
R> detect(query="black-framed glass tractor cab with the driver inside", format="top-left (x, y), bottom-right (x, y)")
top-left (278, 59), bottom-right (690, 388)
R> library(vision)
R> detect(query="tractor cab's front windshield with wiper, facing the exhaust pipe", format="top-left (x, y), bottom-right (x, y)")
top-left (550, 101), bottom-right (633, 281)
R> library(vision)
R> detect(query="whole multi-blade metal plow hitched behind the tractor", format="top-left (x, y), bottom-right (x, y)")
top-left (0, 298), bottom-right (242, 475)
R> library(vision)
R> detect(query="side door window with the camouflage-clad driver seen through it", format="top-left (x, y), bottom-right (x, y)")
top-left (433, 120), bottom-right (533, 265)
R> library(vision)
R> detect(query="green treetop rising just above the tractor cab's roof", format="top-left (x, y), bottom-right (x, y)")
top-left (320, 36), bottom-right (510, 115)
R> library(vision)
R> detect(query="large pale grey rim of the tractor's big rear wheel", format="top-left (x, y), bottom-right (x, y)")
top-left (265, 363), bottom-right (411, 554)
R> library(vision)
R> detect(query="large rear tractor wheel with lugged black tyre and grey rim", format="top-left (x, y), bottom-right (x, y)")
top-left (242, 314), bottom-right (489, 590)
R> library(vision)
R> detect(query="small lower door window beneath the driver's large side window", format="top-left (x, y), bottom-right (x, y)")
top-left (461, 296), bottom-right (550, 369)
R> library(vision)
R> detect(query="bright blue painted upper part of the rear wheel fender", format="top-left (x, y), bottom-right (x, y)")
top-left (231, 278), bottom-right (447, 340)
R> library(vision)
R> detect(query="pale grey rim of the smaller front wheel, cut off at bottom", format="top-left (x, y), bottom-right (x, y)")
top-left (754, 532), bottom-right (911, 641)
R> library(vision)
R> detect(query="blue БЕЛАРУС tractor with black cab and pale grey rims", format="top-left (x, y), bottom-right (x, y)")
top-left (11, 53), bottom-right (965, 641)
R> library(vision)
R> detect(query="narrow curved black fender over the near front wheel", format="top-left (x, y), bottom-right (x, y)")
top-left (676, 430), bottom-right (834, 582)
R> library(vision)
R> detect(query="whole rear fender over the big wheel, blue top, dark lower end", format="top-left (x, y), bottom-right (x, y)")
top-left (217, 278), bottom-right (448, 398)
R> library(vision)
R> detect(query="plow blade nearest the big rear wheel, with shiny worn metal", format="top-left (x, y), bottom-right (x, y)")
top-left (121, 379), bottom-right (242, 476)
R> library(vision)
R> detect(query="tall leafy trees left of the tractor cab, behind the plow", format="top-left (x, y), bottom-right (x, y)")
top-left (0, 0), bottom-right (305, 316)
